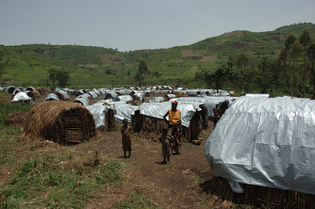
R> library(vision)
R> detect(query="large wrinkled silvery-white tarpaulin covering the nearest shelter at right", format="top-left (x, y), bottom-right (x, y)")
top-left (205, 97), bottom-right (315, 195)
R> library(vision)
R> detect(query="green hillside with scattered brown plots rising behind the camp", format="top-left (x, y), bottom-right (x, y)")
top-left (2, 23), bottom-right (315, 92)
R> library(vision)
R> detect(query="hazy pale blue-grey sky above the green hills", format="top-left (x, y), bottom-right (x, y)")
top-left (0, 0), bottom-right (315, 51)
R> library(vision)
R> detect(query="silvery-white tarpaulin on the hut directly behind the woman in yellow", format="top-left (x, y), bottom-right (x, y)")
top-left (139, 100), bottom-right (201, 127)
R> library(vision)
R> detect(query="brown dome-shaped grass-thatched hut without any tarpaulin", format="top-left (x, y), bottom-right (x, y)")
top-left (24, 100), bottom-right (96, 144)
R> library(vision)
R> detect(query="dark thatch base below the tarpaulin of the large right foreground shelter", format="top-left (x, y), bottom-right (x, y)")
top-left (200, 177), bottom-right (315, 209)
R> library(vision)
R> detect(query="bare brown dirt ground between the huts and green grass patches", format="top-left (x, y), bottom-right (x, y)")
top-left (0, 92), bottom-right (220, 209)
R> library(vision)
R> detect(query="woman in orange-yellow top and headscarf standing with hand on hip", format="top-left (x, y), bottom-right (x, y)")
top-left (163, 101), bottom-right (182, 153)
